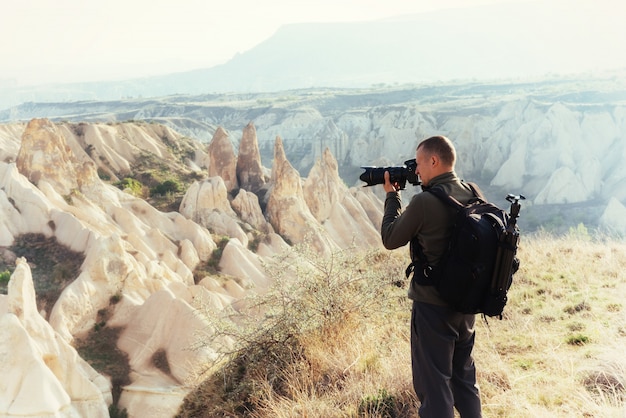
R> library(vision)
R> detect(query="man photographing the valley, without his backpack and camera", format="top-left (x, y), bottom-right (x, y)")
top-left (381, 136), bottom-right (481, 418)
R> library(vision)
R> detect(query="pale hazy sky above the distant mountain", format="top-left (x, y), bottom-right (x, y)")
top-left (0, 0), bottom-right (626, 87)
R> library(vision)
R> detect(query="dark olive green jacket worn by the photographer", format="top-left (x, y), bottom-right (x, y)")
top-left (381, 172), bottom-right (474, 306)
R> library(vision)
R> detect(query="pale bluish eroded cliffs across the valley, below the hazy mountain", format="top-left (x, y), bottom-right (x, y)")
top-left (0, 74), bottom-right (626, 233)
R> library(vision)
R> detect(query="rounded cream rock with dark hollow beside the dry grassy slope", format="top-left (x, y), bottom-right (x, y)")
top-left (118, 285), bottom-right (216, 417)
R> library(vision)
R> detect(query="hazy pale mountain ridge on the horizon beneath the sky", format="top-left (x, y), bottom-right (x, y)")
top-left (0, 0), bottom-right (626, 109)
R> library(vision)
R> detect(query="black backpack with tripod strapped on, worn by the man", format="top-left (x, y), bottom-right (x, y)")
top-left (407, 183), bottom-right (525, 319)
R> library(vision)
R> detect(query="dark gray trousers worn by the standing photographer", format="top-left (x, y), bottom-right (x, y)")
top-left (411, 302), bottom-right (481, 418)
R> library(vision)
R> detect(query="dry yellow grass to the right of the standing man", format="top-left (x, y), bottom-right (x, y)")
top-left (475, 235), bottom-right (626, 417)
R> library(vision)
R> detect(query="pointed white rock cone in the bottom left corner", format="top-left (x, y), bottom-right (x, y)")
top-left (0, 259), bottom-right (111, 418)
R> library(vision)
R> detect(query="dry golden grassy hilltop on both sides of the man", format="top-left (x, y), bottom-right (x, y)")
top-left (179, 234), bottom-right (626, 418)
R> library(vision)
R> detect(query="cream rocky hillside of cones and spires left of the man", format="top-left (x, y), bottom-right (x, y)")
top-left (0, 119), bottom-right (382, 417)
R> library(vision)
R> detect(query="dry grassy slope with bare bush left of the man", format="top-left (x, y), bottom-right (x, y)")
top-left (179, 247), bottom-right (415, 417)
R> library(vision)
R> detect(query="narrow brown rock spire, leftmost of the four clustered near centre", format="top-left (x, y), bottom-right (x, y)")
top-left (205, 126), bottom-right (238, 192)
